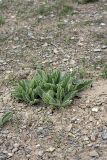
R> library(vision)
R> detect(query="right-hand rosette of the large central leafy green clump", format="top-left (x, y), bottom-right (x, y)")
top-left (42, 70), bottom-right (91, 108)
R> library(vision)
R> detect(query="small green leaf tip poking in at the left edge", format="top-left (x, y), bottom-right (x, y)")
top-left (0, 112), bottom-right (13, 127)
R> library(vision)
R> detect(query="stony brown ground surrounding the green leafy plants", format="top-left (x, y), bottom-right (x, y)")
top-left (0, 0), bottom-right (107, 160)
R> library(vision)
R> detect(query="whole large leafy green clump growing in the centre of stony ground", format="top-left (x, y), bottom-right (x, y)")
top-left (12, 70), bottom-right (91, 108)
